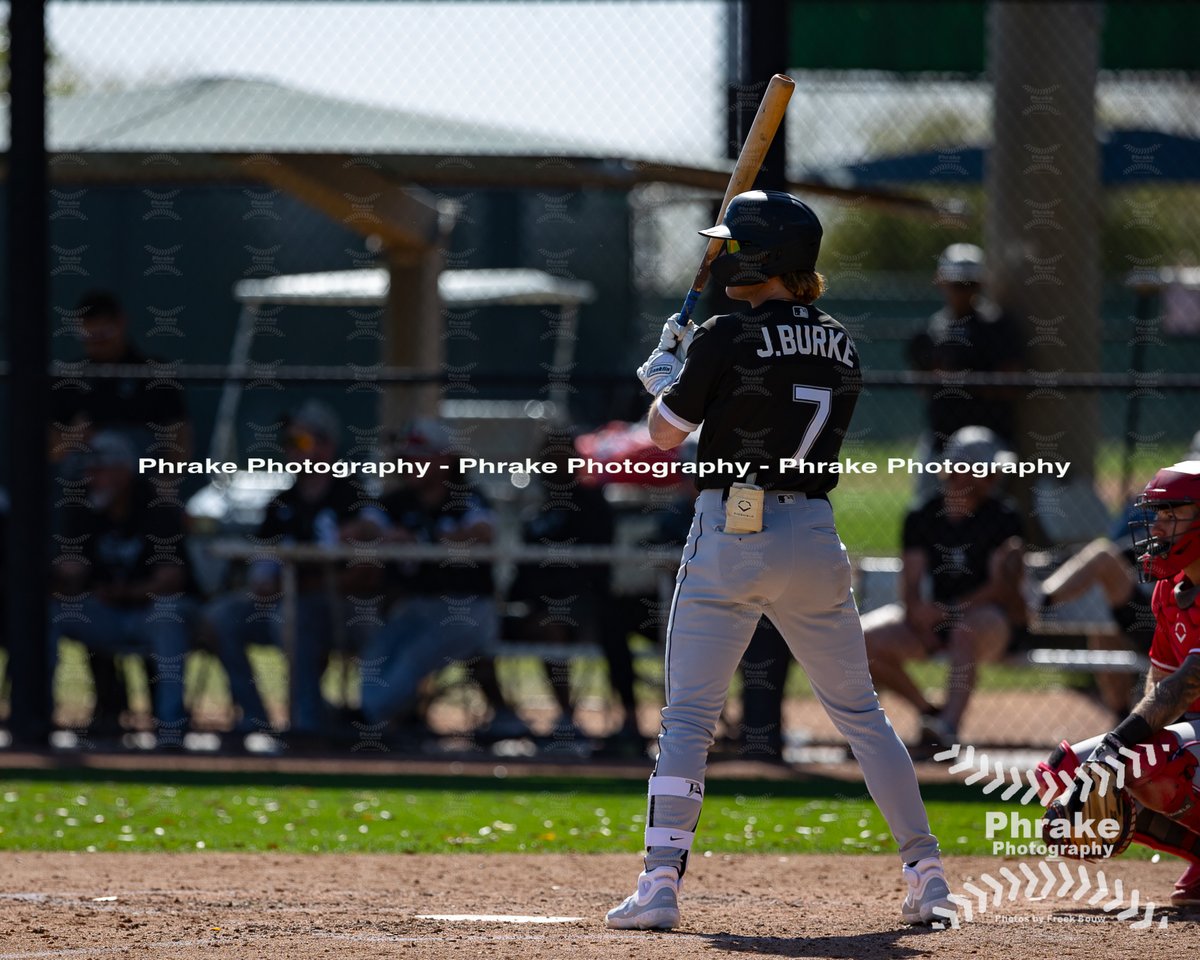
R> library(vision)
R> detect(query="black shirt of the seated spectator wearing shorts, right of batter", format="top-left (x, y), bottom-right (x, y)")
top-left (904, 494), bottom-right (1021, 604)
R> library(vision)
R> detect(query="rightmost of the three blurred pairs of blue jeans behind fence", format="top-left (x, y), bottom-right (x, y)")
top-left (359, 596), bottom-right (499, 724)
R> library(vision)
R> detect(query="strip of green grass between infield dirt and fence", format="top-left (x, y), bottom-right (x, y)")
top-left (0, 772), bottom-right (1156, 856)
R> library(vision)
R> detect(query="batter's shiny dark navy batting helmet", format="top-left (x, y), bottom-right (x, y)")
top-left (701, 190), bottom-right (823, 287)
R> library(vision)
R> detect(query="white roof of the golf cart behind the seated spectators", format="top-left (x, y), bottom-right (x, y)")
top-left (233, 268), bottom-right (595, 307)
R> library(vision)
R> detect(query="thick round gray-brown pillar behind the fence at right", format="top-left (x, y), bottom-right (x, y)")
top-left (985, 2), bottom-right (1103, 501)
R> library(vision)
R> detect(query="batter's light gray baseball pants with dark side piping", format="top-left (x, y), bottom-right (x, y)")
top-left (646, 490), bottom-right (938, 874)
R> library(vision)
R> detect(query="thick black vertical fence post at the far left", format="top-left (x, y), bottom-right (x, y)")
top-left (4, 0), bottom-right (50, 746)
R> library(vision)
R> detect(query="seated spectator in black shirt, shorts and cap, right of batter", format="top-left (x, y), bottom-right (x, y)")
top-left (863, 426), bottom-right (1024, 748)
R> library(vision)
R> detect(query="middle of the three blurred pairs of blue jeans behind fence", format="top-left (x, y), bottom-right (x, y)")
top-left (204, 593), bottom-right (371, 733)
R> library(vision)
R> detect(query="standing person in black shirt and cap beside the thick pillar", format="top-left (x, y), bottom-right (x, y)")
top-left (908, 244), bottom-right (1022, 503)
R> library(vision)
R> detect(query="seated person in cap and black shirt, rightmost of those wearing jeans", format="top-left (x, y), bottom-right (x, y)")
top-left (360, 419), bottom-right (499, 726)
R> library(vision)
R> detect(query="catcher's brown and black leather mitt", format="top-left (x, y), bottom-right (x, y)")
top-left (1042, 760), bottom-right (1136, 860)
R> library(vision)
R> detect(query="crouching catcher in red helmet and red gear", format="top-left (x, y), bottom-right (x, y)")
top-left (1038, 460), bottom-right (1200, 906)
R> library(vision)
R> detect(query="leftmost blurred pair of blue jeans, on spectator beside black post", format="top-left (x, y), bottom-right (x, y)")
top-left (49, 596), bottom-right (197, 732)
